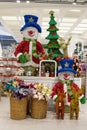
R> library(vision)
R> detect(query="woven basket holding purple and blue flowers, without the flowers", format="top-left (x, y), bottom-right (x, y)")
top-left (10, 97), bottom-right (28, 120)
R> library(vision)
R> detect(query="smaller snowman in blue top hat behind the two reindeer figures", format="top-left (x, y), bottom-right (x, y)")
top-left (51, 59), bottom-right (86, 105)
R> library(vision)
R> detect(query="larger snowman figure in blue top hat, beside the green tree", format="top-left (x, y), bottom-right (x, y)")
top-left (14, 15), bottom-right (45, 64)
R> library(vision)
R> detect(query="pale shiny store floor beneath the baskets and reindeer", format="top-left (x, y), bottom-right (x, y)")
top-left (0, 97), bottom-right (87, 130)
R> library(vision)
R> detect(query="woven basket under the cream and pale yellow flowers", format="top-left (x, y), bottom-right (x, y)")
top-left (31, 98), bottom-right (47, 119)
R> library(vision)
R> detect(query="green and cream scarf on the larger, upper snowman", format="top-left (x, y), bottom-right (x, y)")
top-left (23, 37), bottom-right (41, 58)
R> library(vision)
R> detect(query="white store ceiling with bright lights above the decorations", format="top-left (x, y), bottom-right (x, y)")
top-left (0, 0), bottom-right (87, 41)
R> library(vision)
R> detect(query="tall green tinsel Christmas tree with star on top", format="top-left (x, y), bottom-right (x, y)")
top-left (45, 11), bottom-right (63, 60)
